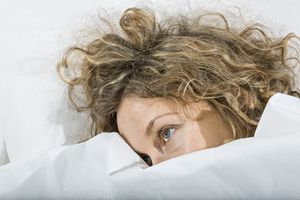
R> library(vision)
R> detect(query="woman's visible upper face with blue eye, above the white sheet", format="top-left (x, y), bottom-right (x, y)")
top-left (117, 97), bottom-right (230, 164)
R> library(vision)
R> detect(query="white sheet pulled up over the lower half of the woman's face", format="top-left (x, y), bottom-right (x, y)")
top-left (0, 94), bottom-right (300, 199)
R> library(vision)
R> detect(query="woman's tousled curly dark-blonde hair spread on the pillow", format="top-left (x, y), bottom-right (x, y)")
top-left (57, 7), bottom-right (300, 139)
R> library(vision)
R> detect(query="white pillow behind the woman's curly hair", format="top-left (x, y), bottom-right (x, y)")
top-left (0, 0), bottom-right (300, 164)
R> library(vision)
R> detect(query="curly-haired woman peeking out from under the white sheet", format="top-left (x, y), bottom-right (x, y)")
top-left (57, 8), bottom-right (300, 165)
